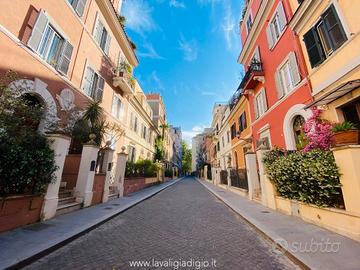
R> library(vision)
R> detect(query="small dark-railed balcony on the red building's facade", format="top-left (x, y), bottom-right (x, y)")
top-left (239, 61), bottom-right (265, 91)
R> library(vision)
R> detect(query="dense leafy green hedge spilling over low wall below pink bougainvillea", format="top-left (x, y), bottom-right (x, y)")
top-left (263, 149), bottom-right (341, 206)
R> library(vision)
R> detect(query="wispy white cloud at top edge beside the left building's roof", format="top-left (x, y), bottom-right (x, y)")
top-left (122, 0), bottom-right (157, 34)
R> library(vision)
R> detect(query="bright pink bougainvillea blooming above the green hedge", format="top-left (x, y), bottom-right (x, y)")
top-left (304, 107), bottom-right (333, 152)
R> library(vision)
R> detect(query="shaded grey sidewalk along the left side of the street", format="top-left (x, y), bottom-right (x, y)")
top-left (0, 178), bottom-right (182, 269)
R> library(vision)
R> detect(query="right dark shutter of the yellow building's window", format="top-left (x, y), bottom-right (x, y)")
top-left (322, 5), bottom-right (347, 50)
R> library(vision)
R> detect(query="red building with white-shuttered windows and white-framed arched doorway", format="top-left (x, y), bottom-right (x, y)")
top-left (238, 0), bottom-right (312, 149)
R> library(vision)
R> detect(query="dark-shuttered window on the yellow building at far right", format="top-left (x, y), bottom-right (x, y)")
top-left (304, 5), bottom-right (347, 68)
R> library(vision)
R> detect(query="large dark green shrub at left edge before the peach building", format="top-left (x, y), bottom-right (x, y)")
top-left (0, 71), bottom-right (57, 196)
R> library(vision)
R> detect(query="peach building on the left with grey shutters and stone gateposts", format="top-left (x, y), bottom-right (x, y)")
top-left (0, 0), bottom-right (138, 224)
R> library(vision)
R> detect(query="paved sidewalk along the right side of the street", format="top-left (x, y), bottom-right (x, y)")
top-left (198, 179), bottom-right (360, 270)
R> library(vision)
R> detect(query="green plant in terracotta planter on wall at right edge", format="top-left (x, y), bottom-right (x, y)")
top-left (332, 121), bottom-right (360, 146)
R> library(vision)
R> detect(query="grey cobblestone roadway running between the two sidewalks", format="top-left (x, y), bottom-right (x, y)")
top-left (23, 178), bottom-right (296, 270)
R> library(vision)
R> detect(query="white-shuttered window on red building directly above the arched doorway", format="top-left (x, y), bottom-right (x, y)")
top-left (275, 52), bottom-right (301, 99)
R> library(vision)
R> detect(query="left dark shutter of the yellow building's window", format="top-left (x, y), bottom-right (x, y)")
top-left (304, 28), bottom-right (325, 68)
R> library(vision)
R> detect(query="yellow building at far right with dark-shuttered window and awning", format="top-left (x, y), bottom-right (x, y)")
top-left (290, 0), bottom-right (360, 124)
